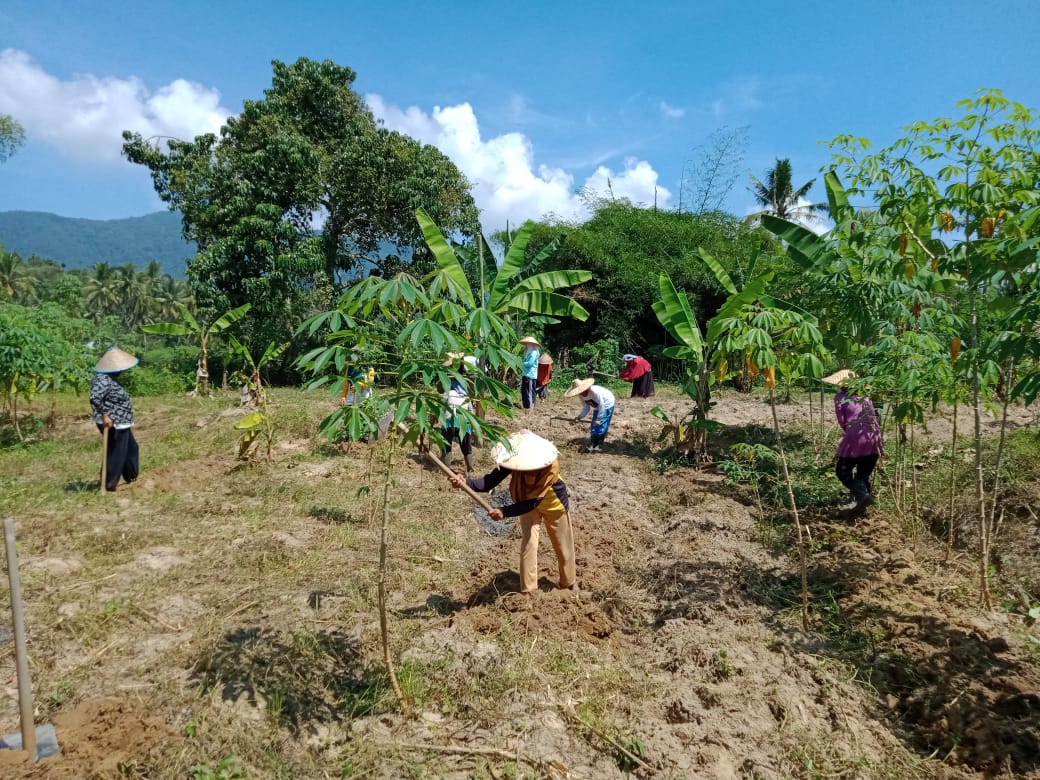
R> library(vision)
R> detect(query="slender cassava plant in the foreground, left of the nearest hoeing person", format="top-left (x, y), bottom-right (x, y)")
top-left (298, 266), bottom-right (519, 709)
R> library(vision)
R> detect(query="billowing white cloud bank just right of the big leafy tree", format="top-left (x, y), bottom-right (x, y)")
top-left (366, 95), bottom-right (671, 230)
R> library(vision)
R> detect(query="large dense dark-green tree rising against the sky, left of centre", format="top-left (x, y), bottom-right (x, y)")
top-left (124, 58), bottom-right (476, 359)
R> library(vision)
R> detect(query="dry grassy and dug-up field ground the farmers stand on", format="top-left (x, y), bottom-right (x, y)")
top-left (0, 391), bottom-right (1040, 779)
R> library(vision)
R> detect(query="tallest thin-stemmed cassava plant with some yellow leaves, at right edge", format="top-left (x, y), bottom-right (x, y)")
top-left (819, 90), bottom-right (1040, 607)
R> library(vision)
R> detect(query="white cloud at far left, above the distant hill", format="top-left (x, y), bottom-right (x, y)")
top-left (0, 49), bottom-right (230, 163)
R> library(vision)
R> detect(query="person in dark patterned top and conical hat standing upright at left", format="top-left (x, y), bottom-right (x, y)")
top-left (90, 346), bottom-right (140, 491)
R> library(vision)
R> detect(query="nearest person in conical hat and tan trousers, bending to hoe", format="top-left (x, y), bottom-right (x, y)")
top-left (449, 428), bottom-right (577, 594)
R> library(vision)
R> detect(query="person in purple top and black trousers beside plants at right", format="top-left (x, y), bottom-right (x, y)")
top-left (823, 368), bottom-right (885, 517)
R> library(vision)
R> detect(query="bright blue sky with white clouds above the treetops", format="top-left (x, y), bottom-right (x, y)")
top-left (0, 0), bottom-right (1040, 230)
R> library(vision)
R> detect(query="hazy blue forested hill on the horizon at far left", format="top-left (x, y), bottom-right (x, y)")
top-left (0, 211), bottom-right (196, 278)
